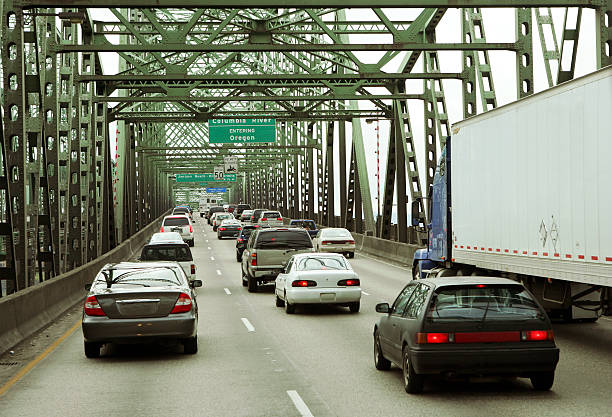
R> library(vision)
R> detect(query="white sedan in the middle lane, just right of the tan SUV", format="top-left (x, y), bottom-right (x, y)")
top-left (274, 253), bottom-right (361, 314)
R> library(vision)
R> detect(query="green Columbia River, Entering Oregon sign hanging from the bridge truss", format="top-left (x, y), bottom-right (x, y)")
top-left (208, 118), bottom-right (276, 143)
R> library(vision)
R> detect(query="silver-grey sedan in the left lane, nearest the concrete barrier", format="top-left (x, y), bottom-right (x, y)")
top-left (82, 262), bottom-right (202, 358)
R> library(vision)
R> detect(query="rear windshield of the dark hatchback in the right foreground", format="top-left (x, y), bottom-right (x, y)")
top-left (427, 284), bottom-right (543, 321)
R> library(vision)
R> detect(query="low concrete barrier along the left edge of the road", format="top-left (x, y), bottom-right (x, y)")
top-left (0, 214), bottom-right (166, 354)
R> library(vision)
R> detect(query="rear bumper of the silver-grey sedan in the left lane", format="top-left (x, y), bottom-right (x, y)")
top-left (81, 312), bottom-right (198, 343)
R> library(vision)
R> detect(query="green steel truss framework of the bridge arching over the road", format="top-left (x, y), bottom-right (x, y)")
top-left (0, 0), bottom-right (612, 296)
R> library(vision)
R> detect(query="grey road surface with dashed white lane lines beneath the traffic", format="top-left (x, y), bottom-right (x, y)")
top-left (0, 217), bottom-right (612, 417)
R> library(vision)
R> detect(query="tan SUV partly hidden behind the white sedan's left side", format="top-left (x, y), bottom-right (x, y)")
top-left (242, 227), bottom-right (314, 292)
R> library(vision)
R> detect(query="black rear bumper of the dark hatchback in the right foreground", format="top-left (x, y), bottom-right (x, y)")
top-left (410, 348), bottom-right (559, 376)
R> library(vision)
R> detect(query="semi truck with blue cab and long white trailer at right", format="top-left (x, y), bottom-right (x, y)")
top-left (414, 67), bottom-right (612, 320)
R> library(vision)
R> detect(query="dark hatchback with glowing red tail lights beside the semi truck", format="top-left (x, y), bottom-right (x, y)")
top-left (374, 276), bottom-right (559, 393)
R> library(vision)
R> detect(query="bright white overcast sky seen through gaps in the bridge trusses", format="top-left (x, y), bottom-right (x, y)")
top-left (90, 8), bottom-right (596, 214)
